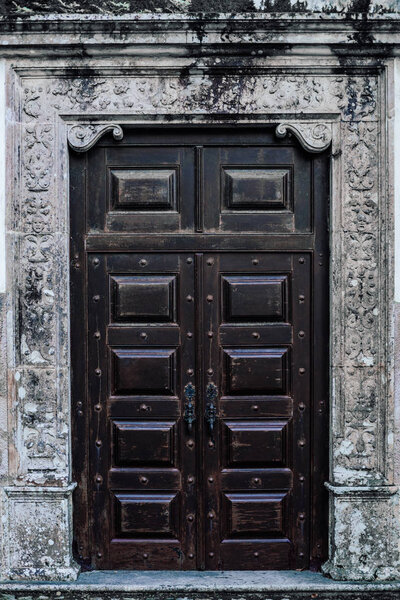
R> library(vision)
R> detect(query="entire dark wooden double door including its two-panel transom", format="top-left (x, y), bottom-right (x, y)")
top-left (71, 128), bottom-right (328, 570)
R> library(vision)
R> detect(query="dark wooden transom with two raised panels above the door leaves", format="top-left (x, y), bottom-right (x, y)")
top-left (87, 130), bottom-right (312, 233)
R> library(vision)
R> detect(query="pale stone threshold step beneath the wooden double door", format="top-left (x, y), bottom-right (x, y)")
top-left (0, 571), bottom-right (400, 600)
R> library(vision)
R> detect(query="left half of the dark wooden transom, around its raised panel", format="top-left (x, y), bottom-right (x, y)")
top-left (87, 145), bottom-right (194, 233)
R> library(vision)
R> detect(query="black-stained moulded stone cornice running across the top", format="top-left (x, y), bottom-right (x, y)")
top-left (0, 12), bottom-right (400, 57)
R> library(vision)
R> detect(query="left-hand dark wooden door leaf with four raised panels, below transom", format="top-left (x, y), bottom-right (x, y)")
top-left (88, 254), bottom-right (196, 568)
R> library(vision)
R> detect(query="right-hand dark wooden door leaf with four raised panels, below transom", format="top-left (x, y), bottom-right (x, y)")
top-left (204, 253), bottom-right (311, 569)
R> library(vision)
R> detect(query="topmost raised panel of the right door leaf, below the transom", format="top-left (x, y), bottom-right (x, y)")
top-left (222, 275), bottom-right (288, 322)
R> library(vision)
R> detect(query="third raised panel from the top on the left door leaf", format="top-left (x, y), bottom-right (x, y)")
top-left (113, 421), bottom-right (175, 467)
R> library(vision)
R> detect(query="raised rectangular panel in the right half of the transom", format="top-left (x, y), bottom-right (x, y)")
top-left (222, 166), bottom-right (291, 211)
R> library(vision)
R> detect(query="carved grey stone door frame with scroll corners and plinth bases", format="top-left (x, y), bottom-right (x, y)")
top-left (2, 59), bottom-right (400, 580)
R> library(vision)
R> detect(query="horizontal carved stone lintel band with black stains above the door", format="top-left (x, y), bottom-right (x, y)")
top-left (22, 72), bottom-right (377, 122)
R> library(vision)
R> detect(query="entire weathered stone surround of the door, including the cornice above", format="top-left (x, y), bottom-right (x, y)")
top-left (0, 0), bottom-right (400, 580)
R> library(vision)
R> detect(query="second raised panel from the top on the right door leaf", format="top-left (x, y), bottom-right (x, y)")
top-left (224, 348), bottom-right (289, 395)
